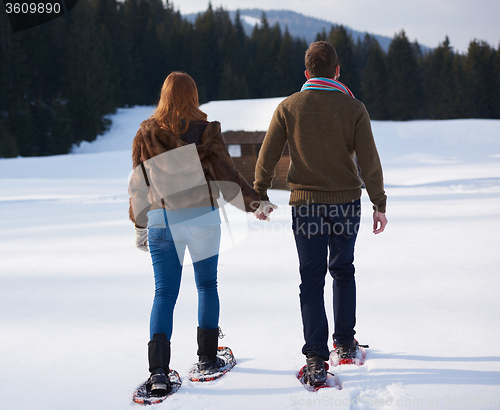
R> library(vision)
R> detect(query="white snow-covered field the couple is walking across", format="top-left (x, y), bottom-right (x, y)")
top-left (0, 99), bottom-right (500, 410)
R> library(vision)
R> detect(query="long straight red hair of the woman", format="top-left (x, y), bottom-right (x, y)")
top-left (153, 71), bottom-right (207, 136)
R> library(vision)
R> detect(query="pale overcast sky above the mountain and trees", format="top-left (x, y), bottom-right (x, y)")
top-left (170, 0), bottom-right (500, 52)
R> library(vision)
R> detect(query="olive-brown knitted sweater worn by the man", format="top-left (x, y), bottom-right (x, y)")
top-left (254, 90), bottom-right (386, 212)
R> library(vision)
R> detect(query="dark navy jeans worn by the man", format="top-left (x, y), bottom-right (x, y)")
top-left (292, 200), bottom-right (361, 360)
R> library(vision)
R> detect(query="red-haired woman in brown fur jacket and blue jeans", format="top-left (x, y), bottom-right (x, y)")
top-left (129, 72), bottom-right (268, 396)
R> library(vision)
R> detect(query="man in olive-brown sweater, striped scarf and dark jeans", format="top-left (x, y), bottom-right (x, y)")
top-left (254, 41), bottom-right (387, 386)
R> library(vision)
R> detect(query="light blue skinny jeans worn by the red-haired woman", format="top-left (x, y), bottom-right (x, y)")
top-left (148, 211), bottom-right (221, 340)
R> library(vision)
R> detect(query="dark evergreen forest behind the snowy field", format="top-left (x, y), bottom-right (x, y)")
top-left (0, 0), bottom-right (500, 158)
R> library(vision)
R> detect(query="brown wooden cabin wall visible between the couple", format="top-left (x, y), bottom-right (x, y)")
top-left (223, 131), bottom-right (290, 189)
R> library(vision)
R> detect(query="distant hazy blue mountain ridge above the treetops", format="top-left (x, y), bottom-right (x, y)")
top-left (184, 9), bottom-right (398, 51)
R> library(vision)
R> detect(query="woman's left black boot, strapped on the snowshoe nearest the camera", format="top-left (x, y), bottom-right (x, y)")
top-left (148, 333), bottom-right (172, 396)
